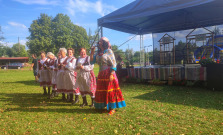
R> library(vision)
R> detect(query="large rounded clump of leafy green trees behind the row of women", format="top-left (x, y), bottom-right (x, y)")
top-left (27, 14), bottom-right (90, 56)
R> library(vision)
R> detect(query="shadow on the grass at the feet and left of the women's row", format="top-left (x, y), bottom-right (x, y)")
top-left (0, 93), bottom-right (98, 114)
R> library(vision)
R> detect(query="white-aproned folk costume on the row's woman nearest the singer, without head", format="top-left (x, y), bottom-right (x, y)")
top-left (76, 56), bottom-right (96, 107)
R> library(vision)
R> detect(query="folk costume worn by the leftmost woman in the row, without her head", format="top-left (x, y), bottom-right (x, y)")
top-left (37, 58), bottom-right (51, 95)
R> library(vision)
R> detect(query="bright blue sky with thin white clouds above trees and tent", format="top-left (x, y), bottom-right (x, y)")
top-left (0, 0), bottom-right (152, 51)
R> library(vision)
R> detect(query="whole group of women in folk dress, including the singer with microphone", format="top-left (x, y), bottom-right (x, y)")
top-left (38, 37), bottom-right (126, 115)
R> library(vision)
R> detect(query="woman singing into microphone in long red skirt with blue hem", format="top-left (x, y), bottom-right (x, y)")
top-left (91, 37), bottom-right (126, 115)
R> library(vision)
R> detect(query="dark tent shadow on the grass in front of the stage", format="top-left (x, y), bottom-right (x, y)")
top-left (130, 86), bottom-right (223, 110)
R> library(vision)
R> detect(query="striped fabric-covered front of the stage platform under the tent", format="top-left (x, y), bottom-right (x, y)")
top-left (127, 64), bottom-right (207, 81)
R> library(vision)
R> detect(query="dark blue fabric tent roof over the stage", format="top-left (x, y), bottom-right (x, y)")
top-left (98, 0), bottom-right (223, 35)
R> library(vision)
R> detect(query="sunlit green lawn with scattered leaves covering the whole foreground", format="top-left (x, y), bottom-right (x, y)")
top-left (0, 67), bottom-right (223, 135)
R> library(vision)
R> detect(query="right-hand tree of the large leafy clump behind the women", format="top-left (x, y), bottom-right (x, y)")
top-left (52, 14), bottom-right (90, 56)
